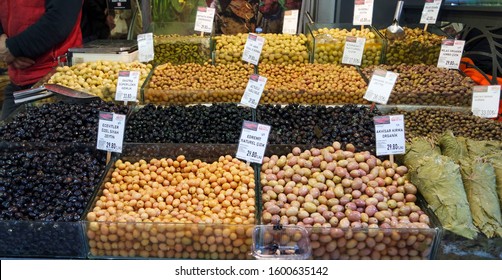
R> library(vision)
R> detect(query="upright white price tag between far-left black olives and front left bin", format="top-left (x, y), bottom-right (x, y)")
top-left (96, 112), bottom-right (126, 153)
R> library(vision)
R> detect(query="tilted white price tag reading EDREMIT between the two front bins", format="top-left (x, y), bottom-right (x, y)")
top-left (236, 121), bottom-right (270, 163)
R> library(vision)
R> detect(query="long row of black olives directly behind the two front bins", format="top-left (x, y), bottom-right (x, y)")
top-left (125, 104), bottom-right (380, 154)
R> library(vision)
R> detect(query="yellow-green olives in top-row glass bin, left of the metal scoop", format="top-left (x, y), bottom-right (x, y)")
top-left (308, 28), bottom-right (384, 67)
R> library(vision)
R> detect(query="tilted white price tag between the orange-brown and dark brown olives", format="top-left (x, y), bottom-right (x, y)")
top-left (364, 69), bottom-right (399, 104)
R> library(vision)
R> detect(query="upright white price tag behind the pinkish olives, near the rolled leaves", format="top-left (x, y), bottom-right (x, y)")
top-left (373, 115), bottom-right (406, 156)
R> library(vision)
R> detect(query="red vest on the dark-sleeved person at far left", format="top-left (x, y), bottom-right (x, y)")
top-left (0, 0), bottom-right (82, 85)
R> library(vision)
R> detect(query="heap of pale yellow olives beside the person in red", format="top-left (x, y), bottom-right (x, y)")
top-left (48, 61), bottom-right (152, 101)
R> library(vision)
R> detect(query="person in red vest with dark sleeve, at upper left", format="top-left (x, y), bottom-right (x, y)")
top-left (0, 0), bottom-right (83, 120)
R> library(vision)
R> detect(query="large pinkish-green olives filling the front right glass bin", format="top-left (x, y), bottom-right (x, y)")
top-left (261, 142), bottom-right (436, 259)
